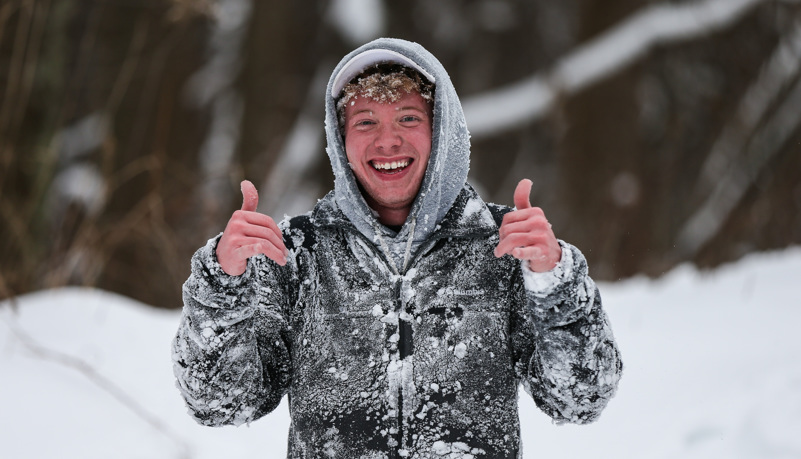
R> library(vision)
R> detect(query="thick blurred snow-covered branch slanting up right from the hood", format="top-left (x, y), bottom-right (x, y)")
top-left (463, 0), bottom-right (766, 137)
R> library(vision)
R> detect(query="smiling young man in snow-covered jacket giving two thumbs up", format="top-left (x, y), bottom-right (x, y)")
top-left (174, 39), bottom-right (622, 458)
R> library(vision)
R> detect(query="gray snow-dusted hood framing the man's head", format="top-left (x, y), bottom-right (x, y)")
top-left (325, 38), bottom-right (470, 271)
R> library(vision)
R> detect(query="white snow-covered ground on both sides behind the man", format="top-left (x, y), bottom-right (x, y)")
top-left (0, 248), bottom-right (801, 459)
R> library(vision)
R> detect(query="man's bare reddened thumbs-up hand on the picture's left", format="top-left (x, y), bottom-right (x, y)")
top-left (217, 180), bottom-right (288, 276)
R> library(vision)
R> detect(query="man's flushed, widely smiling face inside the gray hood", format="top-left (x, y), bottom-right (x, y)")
top-left (345, 92), bottom-right (432, 225)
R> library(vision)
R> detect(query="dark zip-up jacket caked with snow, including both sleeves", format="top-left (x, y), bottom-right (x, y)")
top-left (173, 186), bottom-right (622, 459)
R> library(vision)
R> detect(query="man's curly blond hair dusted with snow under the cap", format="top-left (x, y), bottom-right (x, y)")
top-left (336, 62), bottom-right (434, 133)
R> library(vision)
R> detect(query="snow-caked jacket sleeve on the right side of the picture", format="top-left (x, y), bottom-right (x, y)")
top-left (513, 241), bottom-right (623, 424)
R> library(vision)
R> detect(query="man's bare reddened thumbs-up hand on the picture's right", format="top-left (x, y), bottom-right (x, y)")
top-left (495, 179), bottom-right (562, 273)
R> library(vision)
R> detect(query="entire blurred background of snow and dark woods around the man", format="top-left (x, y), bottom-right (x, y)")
top-left (0, 0), bottom-right (801, 458)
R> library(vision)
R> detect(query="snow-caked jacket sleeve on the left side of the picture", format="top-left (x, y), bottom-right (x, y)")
top-left (173, 236), bottom-right (296, 426)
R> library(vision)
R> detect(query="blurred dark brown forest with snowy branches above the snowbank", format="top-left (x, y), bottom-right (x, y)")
top-left (0, 0), bottom-right (801, 307)
